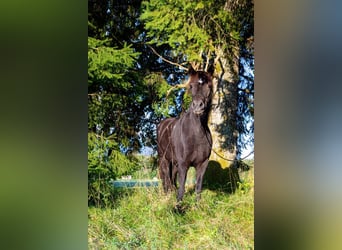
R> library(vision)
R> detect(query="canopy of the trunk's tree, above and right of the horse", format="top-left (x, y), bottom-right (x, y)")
top-left (140, 0), bottom-right (254, 158)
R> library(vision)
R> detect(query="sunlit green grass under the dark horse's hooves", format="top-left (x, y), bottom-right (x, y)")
top-left (88, 161), bottom-right (254, 249)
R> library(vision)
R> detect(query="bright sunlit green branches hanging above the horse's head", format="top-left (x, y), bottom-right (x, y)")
top-left (140, 0), bottom-right (239, 62)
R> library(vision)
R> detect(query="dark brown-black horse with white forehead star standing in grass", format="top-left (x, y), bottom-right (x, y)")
top-left (157, 67), bottom-right (214, 202)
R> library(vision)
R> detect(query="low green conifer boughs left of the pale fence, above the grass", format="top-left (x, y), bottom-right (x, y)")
top-left (88, 133), bottom-right (140, 206)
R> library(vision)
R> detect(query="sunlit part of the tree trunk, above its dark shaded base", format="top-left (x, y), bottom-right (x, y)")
top-left (208, 47), bottom-right (239, 169)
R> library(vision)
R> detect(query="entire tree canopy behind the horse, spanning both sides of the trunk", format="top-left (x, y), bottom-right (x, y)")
top-left (88, 0), bottom-right (254, 184)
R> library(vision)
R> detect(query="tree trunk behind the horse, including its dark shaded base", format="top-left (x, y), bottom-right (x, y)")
top-left (204, 46), bottom-right (240, 193)
